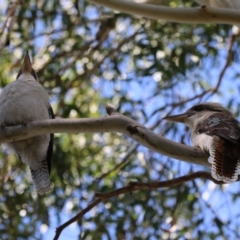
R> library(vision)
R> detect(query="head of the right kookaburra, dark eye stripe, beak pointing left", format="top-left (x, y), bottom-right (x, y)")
top-left (163, 102), bottom-right (233, 128)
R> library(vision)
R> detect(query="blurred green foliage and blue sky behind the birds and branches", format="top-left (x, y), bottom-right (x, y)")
top-left (0, 0), bottom-right (240, 240)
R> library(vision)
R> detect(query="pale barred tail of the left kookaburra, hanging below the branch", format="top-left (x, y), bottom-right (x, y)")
top-left (30, 161), bottom-right (51, 195)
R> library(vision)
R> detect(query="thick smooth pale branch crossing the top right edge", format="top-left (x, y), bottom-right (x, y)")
top-left (88, 0), bottom-right (240, 24)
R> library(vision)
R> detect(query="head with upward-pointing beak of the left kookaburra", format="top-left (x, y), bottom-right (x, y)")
top-left (17, 51), bottom-right (39, 82)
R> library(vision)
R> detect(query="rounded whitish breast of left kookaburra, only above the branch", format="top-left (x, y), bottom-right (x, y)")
top-left (0, 80), bottom-right (49, 126)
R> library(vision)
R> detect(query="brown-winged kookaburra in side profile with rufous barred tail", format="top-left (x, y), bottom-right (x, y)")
top-left (164, 102), bottom-right (240, 183)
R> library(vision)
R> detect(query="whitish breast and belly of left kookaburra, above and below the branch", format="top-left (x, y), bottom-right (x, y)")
top-left (0, 78), bottom-right (50, 170)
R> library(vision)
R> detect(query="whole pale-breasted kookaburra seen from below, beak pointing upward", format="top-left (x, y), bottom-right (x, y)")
top-left (0, 52), bottom-right (54, 194)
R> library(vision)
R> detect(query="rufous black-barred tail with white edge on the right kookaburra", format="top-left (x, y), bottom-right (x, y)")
top-left (208, 136), bottom-right (240, 183)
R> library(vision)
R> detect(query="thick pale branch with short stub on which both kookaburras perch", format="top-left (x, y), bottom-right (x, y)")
top-left (0, 106), bottom-right (210, 166)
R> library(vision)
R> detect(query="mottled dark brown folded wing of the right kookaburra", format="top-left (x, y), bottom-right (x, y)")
top-left (196, 113), bottom-right (240, 143)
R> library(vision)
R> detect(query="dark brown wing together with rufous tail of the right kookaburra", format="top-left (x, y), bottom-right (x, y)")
top-left (196, 112), bottom-right (240, 183)
